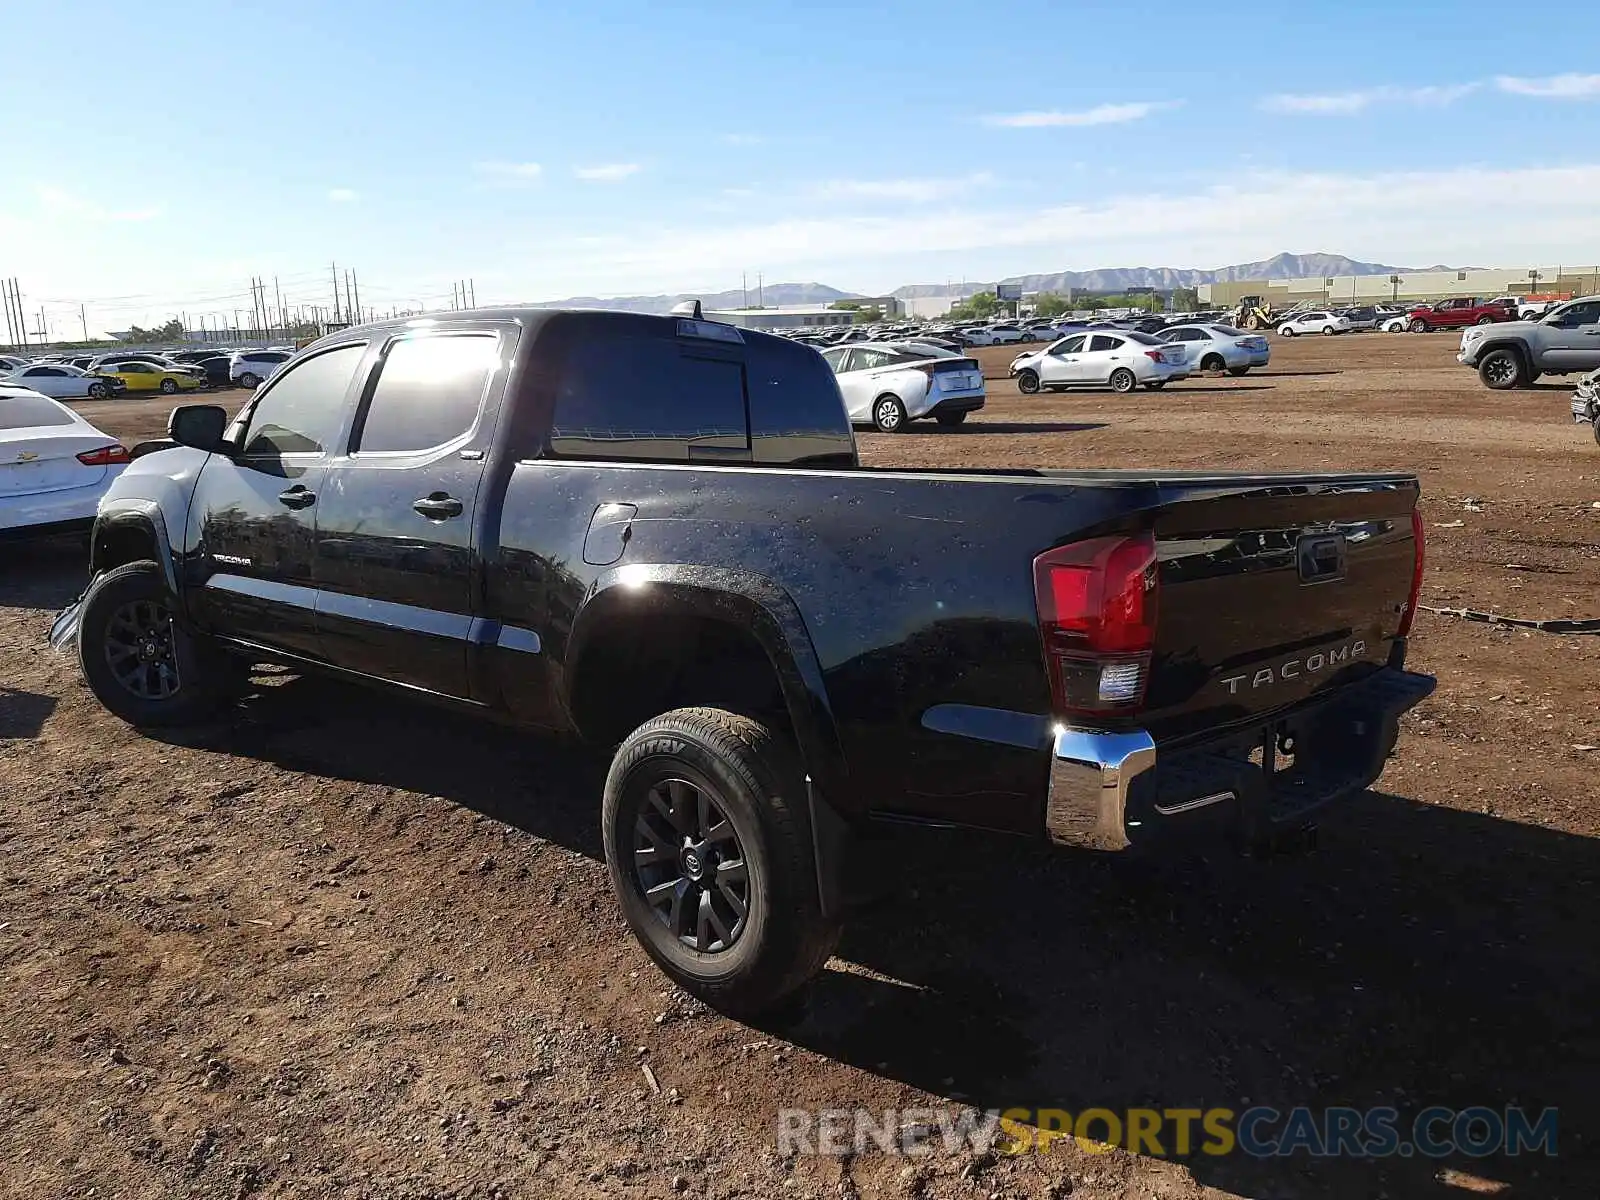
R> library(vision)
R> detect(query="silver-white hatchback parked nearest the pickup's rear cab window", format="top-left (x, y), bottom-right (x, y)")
top-left (822, 342), bottom-right (984, 434)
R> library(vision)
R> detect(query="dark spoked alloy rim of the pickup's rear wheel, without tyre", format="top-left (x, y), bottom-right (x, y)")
top-left (634, 779), bottom-right (750, 954)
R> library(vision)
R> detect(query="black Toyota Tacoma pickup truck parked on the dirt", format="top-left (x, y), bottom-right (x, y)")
top-left (51, 309), bottom-right (1434, 1011)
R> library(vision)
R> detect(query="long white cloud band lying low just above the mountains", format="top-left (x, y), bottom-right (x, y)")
top-left (512, 163), bottom-right (1600, 296)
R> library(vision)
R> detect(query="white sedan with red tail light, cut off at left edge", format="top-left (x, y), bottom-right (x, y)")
top-left (0, 387), bottom-right (130, 536)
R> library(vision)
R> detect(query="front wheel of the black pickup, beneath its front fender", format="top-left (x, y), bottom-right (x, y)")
top-left (78, 560), bottom-right (230, 726)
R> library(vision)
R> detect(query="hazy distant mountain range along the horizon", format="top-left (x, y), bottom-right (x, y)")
top-left (533, 253), bottom-right (1474, 312)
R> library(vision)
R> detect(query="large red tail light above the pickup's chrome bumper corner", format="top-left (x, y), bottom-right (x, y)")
top-left (1034, 533), bottom-right (1158, 717)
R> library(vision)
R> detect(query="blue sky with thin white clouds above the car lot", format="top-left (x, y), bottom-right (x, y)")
top-left (0, 0), bottom-right (1600, 331)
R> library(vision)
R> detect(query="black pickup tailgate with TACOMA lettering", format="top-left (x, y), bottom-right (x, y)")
top-left (1144, 477), bottom-right (1418, 741)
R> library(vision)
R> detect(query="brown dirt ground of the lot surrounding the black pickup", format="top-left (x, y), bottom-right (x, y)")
top-left (0, 334), bottom-right (1600, 1200)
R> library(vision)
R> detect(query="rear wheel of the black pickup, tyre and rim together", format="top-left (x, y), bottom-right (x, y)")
top-left (602, 709), bottom-right (840, 1014)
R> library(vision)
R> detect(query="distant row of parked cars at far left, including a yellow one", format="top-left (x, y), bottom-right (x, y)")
top-left (0, 349), bottom-right (293, 400)
